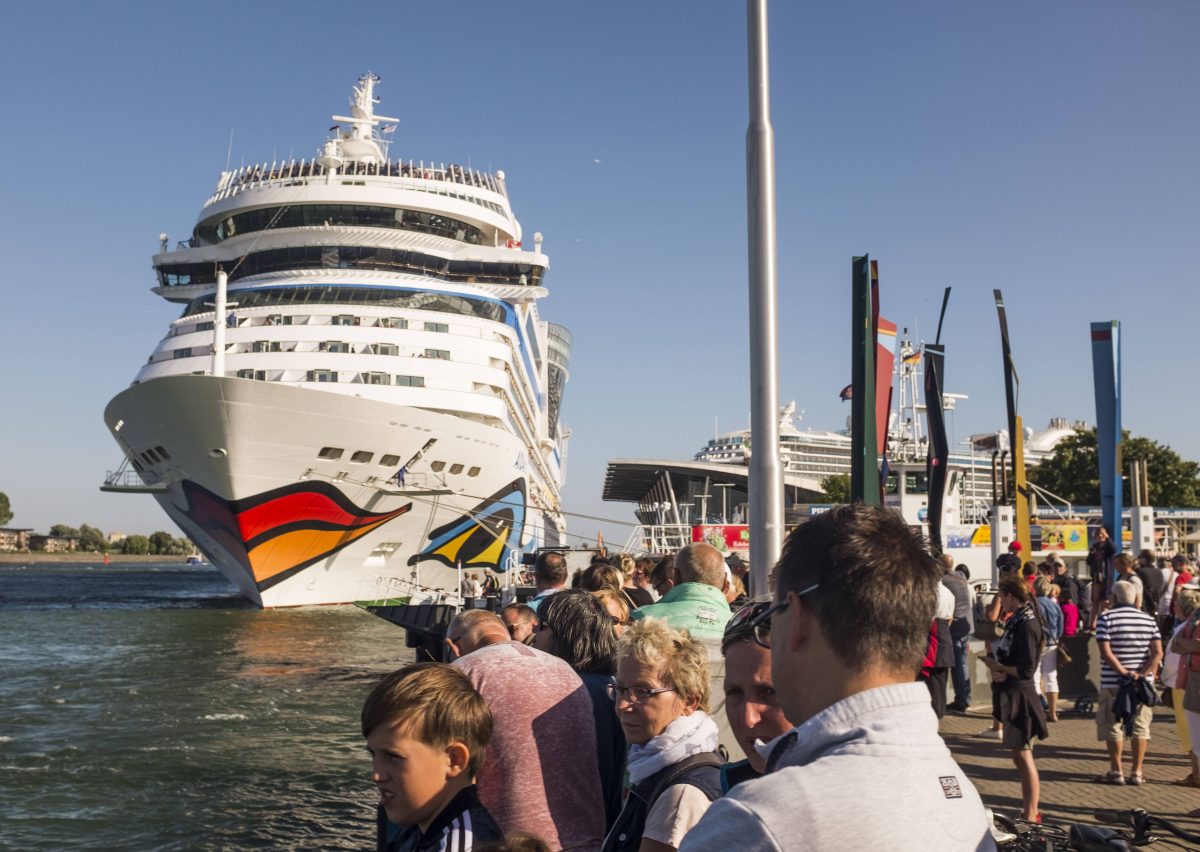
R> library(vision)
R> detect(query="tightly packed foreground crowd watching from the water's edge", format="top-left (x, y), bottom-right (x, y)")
top-left (362, 504), bottom-right (998, 852)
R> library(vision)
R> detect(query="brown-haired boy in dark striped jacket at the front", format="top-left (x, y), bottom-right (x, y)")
top-left (362, 662), bottom-right (503, 852)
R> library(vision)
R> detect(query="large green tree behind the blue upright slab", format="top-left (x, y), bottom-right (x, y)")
top-left (1030, 428), bottom-right (1200, 508)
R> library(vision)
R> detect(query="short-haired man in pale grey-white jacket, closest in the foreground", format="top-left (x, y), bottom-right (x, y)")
top-left (679, 504), bottom-right (995, 852)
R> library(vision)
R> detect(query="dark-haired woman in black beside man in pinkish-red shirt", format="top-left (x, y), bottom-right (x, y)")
top-left (532, 589), bottom-right (625, 828)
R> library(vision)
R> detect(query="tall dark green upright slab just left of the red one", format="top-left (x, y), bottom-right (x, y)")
top-left (850, 254), bottom-right (882, 506)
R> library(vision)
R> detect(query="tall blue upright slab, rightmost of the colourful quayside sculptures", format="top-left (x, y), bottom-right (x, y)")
top-left (1092, 319), bottom-right (1122, 553)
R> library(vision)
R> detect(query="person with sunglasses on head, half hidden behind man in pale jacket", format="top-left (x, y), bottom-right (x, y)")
top-left (721, 596), bottom-right (792, 793)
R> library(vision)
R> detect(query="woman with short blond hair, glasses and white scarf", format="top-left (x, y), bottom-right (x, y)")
top-left (604, 618), bottom-right (722, 852)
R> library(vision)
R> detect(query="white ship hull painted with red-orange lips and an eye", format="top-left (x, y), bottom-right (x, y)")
top-left (104, 376), bottom-right (562, 607)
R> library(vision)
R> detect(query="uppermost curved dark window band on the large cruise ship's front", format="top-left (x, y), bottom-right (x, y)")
top-left (192, 204), bottom-right (484, 246)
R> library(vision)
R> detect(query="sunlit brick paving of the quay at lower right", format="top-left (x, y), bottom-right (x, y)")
top-left (941, 702), bottom-right (1200, 835)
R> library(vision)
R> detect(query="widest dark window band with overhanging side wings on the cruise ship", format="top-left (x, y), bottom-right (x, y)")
top-left (157, 246), bottom-right (545, 287)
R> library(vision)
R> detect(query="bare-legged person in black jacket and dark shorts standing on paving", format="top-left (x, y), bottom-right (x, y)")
top-left (984, 574), bottom-right (1046, 822)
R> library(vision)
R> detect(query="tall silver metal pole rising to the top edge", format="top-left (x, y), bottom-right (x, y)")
top-left (746, 0), bottom-right (784, 595)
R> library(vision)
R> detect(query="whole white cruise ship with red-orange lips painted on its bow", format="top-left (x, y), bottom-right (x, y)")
top-left (103, 73), bottom-right (571, 607)
